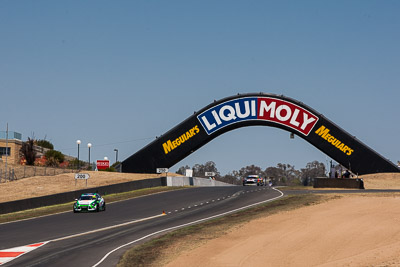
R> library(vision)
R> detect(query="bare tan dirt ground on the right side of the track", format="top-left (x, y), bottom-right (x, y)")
top-left (167, 174), bottom-right (400, 267)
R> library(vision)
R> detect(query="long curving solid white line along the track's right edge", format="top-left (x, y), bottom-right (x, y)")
top-left (92, 188), bottom-right (283, 267)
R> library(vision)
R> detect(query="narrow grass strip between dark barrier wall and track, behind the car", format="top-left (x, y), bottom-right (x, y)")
top-left (0, 186), bottom-right (182, 223)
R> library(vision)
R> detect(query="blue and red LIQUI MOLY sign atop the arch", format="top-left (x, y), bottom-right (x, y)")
top-left (197, 97), bottom-right (318, 136)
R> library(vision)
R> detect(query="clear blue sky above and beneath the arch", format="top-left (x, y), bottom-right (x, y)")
top-left (0, 0), bottom-right (400, 174)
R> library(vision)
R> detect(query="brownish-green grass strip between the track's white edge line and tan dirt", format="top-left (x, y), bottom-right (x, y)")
top-left (117, 194), bottom-right (338, 267)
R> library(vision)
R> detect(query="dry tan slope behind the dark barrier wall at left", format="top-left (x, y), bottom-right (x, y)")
top-left (0, 171), bottom-right (177, 203)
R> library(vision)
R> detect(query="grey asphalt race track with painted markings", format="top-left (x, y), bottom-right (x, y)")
top-left (0, 186), bottom-right (282, 266)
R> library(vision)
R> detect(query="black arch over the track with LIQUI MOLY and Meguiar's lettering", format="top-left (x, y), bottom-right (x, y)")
top-left (122, 93), bottom-right (400, 174)
